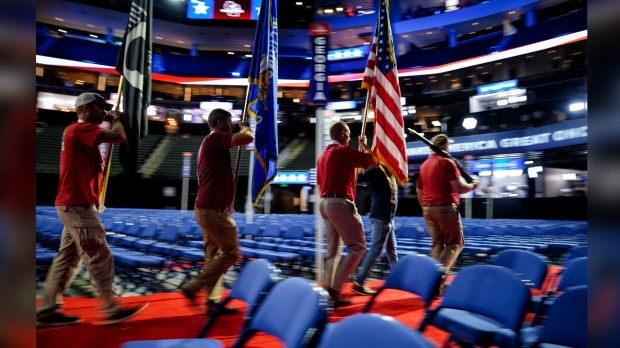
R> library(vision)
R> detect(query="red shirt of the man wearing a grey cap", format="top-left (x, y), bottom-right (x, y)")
top-left (54, 122), bottom-right (103, 207)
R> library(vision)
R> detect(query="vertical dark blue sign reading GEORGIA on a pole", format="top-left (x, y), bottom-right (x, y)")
top-left (308, 23), bottom-right (331, 105)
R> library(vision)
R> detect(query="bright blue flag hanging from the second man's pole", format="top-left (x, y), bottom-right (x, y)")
top-left (247, 0), bottom-right (278, 206)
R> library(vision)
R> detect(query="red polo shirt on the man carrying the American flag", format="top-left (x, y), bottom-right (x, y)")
top-left (316, 144), bottom-right (372, 200)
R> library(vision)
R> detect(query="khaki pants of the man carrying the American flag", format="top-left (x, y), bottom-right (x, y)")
top-left (317, 198), bottom-right (366, 292)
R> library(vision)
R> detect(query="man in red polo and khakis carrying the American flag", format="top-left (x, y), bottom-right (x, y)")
top-left (317, 121), bottom-right (377, 308)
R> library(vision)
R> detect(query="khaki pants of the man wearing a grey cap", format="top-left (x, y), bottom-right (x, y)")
top-left (37, 204), bottom-right (114, 315)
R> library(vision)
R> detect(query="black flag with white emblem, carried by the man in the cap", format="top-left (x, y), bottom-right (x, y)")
top-left (116, 0), bottom-right (153, 180)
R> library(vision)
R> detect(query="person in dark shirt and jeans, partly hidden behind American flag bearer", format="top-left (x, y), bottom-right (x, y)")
top-left (351, 163), bottom-right (398, 296)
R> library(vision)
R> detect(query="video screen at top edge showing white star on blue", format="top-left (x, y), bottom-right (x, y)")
top-left (187, 0), bottom-right (261, 20)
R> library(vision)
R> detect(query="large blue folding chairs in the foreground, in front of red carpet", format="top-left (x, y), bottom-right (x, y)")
top-left (122, 255), bottom-right (587, 348)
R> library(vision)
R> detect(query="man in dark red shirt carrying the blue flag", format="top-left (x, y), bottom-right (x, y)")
top-left (181, 109), bottom-right (254, 315)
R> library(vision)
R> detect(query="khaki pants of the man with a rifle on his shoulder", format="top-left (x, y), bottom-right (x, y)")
top-left (422, 204), bottom-right (465, 274)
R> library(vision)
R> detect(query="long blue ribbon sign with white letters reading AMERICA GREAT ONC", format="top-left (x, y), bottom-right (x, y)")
top-left (406, 118), bottom-right (588, 159)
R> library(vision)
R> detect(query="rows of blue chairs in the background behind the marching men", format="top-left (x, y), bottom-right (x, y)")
top-left (37, 207), bottom-right (587, 290)
